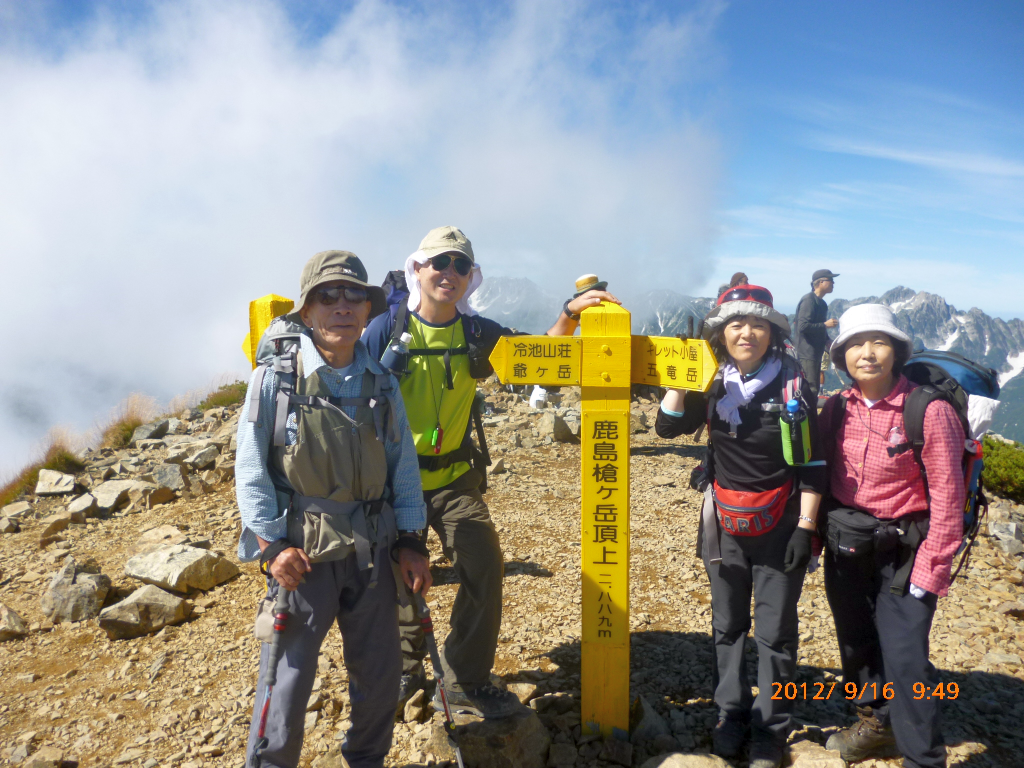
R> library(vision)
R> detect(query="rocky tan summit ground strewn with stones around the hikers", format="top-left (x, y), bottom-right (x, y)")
top-left (0, 390), bottom-right (1024, 768)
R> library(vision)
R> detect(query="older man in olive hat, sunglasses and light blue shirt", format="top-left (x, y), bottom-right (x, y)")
top-left (236, 251), bottom-right (431, 768)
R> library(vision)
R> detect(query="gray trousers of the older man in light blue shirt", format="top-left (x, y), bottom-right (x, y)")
top-left (246, 553), bottom-right (401, 768)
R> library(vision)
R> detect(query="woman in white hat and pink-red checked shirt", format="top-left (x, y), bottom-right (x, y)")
top-left (819, 304), bottom-right (965, 768)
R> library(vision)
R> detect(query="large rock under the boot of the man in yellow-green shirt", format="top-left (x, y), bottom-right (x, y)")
top-left (424, 709), bottom-right (551, 768)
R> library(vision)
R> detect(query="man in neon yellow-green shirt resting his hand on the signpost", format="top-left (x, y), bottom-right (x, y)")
top-left (364, 226), bottom-right (618, 718)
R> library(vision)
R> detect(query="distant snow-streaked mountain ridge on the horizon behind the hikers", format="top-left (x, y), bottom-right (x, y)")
top-left (470, 278), bottom-right (1024, 442)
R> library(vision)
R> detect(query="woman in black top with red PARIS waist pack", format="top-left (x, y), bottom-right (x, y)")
top-left (654, 286), bottom-right (825, 768)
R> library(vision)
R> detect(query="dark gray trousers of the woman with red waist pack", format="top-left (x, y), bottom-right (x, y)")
top-left (701, 494), bottom-right (807, 743)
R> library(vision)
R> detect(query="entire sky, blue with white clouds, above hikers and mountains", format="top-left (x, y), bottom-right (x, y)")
top-left (0, 0), bottom-right (1024, 475)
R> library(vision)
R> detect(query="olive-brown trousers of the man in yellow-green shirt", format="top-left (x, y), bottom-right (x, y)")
top-left (398, 469), bottom-right (505, 690)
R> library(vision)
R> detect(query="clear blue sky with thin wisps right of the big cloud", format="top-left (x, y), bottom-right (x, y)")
top-left (715, 2), bottom-right (1024, 317)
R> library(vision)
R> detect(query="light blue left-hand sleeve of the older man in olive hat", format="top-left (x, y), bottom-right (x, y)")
top-left (234, 368), bottom-right (288, 561)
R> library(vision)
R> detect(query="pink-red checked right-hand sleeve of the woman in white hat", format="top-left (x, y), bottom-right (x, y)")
top-left (910, 400), bottom-right (965, 595)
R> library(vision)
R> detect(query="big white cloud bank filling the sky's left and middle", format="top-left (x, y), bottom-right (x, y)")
top-left (0, 0), bottom-right (722, 473)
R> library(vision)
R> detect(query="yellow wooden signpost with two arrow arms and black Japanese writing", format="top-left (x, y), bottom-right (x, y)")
top-left (490, 304), bottom-right (718, 735)
